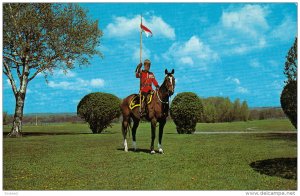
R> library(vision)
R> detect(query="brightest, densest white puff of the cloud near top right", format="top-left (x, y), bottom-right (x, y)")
top-left (221, 5), bottom-right (269, 37)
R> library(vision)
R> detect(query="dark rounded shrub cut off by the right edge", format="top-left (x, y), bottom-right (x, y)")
top-left (280, 81), bottom-right (297, 128)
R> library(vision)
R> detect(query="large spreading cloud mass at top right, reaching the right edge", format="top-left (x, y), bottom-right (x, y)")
top-left (213, 4), bottom-right (297, 57)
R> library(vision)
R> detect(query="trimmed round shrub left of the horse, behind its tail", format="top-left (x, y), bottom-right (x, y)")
top-left (77, 92), bottom-right (121, 133)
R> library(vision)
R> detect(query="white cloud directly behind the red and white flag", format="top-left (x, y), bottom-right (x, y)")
top-left (104, 15), bottom-right (175, 40)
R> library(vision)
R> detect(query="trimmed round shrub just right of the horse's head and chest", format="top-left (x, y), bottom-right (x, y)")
top-left (170, 92), bottom-right (203, 134)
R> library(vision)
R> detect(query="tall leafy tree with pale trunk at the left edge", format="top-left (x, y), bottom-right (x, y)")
top-left (3, 3), bottom-right (102, 137)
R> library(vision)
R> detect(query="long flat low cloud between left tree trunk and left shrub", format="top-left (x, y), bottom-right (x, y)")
top-left (48, 78), bottom-right (105, 91)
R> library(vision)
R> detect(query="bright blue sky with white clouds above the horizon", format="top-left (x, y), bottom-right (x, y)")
top-left (3, 3), bottom-right (297, 114)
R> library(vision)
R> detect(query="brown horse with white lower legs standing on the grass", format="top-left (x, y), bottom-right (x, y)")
top-left (120, 69), bottom-right (175, 154)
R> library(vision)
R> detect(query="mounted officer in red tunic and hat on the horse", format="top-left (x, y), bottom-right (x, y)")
top-left (135, 59), bottom-right (159, 116)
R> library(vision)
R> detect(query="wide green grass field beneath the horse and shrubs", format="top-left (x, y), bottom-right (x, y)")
top-left (3, 120), bottom-right (297, 190)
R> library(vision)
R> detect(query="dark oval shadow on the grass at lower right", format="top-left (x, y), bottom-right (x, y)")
top-left (250, 158), bottom-right (297, 180)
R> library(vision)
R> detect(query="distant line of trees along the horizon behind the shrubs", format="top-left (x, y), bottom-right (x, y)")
top-left (3, 102), bottom-right (286, 125)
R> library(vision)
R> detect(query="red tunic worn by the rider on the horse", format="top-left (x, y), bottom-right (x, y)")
top-left (135, 70), bottom-right (158, 93)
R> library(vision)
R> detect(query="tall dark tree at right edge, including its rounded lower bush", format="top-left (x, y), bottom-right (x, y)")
top-left (280, 37), bottom-right (298, 128)
